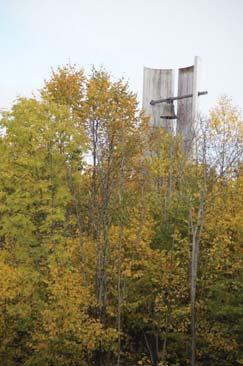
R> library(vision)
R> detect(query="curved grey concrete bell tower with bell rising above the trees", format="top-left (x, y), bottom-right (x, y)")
top-left (143, 56), bottom-right (207, 155)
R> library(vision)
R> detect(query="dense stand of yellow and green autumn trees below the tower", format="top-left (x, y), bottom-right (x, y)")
top-left (0, 65), bottom-right (243, 366)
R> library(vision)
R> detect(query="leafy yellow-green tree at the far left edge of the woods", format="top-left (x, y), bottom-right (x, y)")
top-left (0, 99), bottom-right (85, 364)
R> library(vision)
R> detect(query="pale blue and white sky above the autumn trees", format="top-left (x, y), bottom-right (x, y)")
top-left (0, 0), bottom-right (243, 113)
